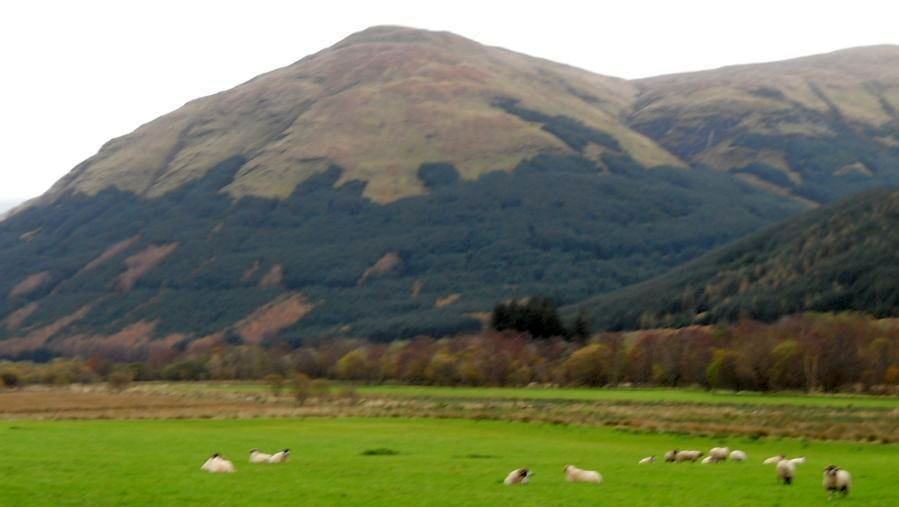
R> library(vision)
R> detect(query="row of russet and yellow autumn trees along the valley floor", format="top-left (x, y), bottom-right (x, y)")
top-left (0, 313), bottom-right (899, 392)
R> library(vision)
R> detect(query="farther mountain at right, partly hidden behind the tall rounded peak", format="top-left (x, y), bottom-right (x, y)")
top-left (628, 46), bottom-right (899, 203)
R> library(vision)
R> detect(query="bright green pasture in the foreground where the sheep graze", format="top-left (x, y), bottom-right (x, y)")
top-left (0, 418), bottom-right (899, 507)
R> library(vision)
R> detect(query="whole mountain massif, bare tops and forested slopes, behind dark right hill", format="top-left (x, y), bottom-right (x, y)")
top-left (0, 27), bottom-right (899, 358)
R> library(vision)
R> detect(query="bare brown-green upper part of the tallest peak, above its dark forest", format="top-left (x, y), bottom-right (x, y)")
top-left (40, 27), bottom-right (681, 203)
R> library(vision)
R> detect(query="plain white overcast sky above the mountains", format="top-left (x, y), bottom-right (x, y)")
top-left (0, 0), bottom-right (899, 200)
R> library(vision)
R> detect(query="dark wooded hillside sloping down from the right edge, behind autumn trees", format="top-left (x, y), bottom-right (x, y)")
top-left (571, 189), bottom-right (899, 329)
